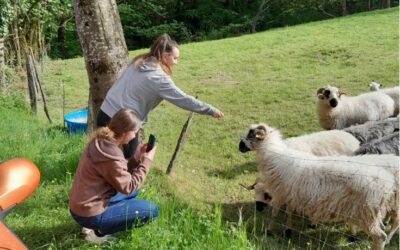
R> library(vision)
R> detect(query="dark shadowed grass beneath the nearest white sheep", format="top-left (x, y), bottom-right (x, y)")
top-left (216, 202), bottom-right (399, 250)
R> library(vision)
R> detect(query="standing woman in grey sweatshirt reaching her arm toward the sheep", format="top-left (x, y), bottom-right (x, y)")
top-left (97, 34), bottom-right (224, 159)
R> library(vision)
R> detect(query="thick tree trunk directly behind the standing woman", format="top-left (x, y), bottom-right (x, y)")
top-left (72, 0), bottom-right (128, 131)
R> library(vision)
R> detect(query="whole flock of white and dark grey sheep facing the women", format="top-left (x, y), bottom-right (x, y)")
top-left (239, 82), bottom-right (400, 249)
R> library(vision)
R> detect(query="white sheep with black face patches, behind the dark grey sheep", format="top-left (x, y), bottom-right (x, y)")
top-left (317, 85), bottom-right (394, 130)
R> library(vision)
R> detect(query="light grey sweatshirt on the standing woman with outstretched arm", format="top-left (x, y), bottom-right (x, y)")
top-left (100, 58), bottom-right (217, 123)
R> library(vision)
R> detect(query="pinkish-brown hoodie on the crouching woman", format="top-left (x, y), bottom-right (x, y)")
top-left (69, 139), bottom-right (151, 217)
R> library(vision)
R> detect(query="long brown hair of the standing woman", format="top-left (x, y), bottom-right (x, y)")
top-left (133, 33), bottom-right (179, 75)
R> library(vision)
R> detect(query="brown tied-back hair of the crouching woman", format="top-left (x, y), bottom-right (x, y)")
top-left (94, 108), bottom-right (141, 141)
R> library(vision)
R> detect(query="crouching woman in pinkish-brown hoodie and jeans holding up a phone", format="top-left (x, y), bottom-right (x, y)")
top-left (69, 109), bottom-right (158, 244)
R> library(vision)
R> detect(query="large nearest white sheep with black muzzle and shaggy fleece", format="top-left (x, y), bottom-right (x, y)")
top-left (242, 124), bottom-right (400, 249)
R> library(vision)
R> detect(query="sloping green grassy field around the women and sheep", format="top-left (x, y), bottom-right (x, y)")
top-left (0, 8), bottom-right (399, 249)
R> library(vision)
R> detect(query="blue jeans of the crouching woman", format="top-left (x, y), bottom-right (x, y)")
top-left (71, 191), bottom-right (158, 234)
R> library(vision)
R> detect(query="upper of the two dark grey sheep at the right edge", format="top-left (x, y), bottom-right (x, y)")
top-left (343, 117), bottom-right (399, 145)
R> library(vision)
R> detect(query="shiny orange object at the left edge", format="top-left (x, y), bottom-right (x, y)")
top-left (0, 158), bottom-right (40, 250)
